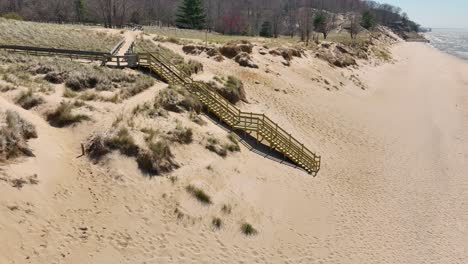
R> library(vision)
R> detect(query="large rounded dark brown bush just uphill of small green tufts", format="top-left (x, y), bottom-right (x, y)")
top-left (137, 141), bottom-right (179, 175)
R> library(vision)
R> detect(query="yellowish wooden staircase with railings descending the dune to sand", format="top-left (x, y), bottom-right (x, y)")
top-left (138, 53), bottom-right (321, 176)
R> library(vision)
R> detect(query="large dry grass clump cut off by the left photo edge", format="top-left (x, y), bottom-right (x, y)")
top-left (0, 110), bottom-right (37, 162)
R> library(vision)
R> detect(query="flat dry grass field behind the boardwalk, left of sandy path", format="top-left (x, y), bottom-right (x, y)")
top-left (0, 18), bottom-right (121, 52)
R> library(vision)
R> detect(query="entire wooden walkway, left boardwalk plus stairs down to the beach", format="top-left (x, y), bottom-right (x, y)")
top-left (0, 42), bottom-right (321, 176)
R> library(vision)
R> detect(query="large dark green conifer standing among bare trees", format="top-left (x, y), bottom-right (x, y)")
top-left (176, 0), bottom-right (206, 29)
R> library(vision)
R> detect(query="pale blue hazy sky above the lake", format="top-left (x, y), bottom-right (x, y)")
top-left (378, 0), bottom-right (468, 28)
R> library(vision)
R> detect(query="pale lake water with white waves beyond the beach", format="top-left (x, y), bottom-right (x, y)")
top-left (426, 29), bottom-right (468, 60)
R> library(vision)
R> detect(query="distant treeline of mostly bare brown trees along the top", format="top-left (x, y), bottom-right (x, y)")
top-left (0, 0), bottom-right (419, 36)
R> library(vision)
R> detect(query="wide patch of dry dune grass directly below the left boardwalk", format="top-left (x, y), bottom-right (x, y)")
top-left (0, 54), bottom-right (154, 103)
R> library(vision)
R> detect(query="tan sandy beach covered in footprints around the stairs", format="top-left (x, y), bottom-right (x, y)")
top-left (0, 40), bottom-right (468, 264)
